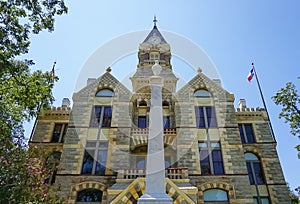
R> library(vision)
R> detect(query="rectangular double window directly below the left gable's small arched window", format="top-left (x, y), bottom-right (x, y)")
top-left (90, 106), bottom-right (112, 128)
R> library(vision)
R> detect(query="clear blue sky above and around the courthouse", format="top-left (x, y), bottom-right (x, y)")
top-left (26, 0), bottom-right (300, 191)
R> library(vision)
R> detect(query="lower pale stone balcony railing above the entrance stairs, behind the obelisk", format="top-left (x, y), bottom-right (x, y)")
top-left (117, 168), bottom-right (188, 179)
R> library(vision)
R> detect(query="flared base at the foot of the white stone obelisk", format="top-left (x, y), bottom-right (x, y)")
top-left (138, 193), bottom-right (173, 204)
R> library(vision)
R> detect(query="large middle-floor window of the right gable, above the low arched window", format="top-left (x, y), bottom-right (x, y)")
top-left (198, 142), bottom-right (224, 174)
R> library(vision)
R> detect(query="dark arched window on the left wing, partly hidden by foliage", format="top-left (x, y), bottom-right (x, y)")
top-left (45, 152), bottom-right (61, 184)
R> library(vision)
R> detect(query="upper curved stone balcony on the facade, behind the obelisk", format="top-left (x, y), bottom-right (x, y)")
top-left (130, 128), bottom-right (176, 150)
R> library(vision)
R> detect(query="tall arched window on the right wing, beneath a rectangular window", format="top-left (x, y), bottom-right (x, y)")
top-left (245, 153), bottom-right (265, 185)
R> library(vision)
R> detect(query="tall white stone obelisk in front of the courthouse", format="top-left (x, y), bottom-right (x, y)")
top-left (138, 60), bottom-right (173, 204)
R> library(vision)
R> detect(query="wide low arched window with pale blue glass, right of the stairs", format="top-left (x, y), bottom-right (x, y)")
top-left (203, 189), bottom-right (229, 203)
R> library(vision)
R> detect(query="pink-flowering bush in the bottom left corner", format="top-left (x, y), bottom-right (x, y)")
top-left (0, 137), bottom-right (66, 204)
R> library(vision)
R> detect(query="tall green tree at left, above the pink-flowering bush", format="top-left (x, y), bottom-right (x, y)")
top-left (0, 0), bottom-right (67, 137)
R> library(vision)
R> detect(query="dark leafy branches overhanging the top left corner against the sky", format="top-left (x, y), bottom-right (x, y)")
top-left (0, 0), bottom-right (67, 63)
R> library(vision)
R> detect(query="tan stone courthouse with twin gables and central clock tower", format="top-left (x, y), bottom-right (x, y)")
top-left (30, 19), bottom-right (290, 204)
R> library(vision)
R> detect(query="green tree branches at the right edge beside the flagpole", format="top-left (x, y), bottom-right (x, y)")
top-left (272, 79), bottom-right (300, 158)
